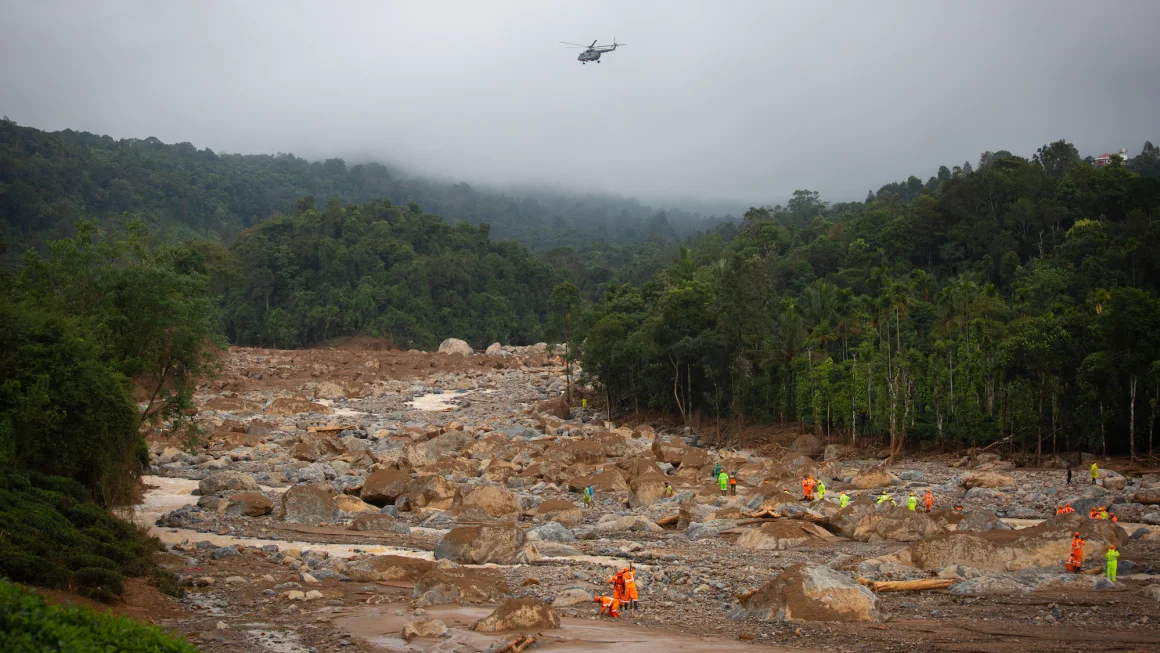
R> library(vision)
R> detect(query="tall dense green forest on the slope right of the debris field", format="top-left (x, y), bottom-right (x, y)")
top-left (568, 142), bottom-right (1160, 455)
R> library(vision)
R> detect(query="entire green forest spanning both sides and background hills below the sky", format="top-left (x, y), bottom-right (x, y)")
top-left (0, 122), bottom-right (1160, 463)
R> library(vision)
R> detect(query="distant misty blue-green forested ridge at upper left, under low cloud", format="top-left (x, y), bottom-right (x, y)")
top-left (0, 119), bottom-right (724, 267)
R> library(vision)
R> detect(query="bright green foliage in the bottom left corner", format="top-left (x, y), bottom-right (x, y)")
top-left (0, 580), bottom-right (197, 653)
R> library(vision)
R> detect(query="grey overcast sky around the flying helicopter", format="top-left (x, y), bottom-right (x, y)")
top-left (0, 0), bottom-right (1160, 204)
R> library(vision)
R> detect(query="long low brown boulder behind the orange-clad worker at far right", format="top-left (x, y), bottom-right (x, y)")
top-left (902, 515), bottom-right (1128, 572)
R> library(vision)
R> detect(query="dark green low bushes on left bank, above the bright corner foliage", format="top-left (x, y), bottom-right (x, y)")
top-left (0, 471), bottom-right (180, 607)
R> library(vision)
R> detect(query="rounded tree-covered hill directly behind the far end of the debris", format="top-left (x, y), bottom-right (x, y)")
top-left (215, 201), bottom-right (559, 348)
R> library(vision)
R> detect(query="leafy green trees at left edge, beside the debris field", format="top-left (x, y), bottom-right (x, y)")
top-left (0, 222), bottom-right (224, 503)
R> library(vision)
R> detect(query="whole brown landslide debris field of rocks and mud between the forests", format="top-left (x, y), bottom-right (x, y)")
top-left (128, 342), bottom-right (1160, 653)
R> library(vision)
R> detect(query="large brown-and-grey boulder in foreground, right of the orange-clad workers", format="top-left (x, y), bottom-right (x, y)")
top-left (738, 564), bottom-right (882, 623)
